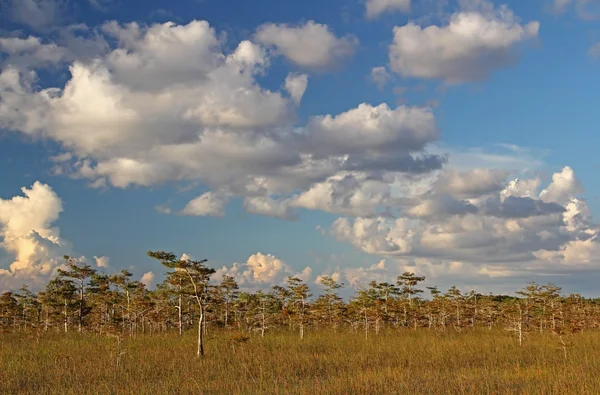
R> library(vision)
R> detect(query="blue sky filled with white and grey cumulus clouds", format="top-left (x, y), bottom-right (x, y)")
top-left (0, 0), bottom-right (600, 296)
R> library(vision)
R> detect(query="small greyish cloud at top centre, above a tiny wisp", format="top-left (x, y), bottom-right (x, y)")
top-left (256, 21), bottom-right (358, 71)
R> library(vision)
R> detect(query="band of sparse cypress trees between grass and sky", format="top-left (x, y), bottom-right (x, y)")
top-left (0, 251), bottom-right (600, 356)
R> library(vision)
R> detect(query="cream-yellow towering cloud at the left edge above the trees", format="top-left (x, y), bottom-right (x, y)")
top-left (0, 182), bottom-right (71, 290)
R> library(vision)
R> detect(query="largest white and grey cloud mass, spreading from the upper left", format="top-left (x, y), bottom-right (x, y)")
top-left (0, 21), bottom-right (445, 223)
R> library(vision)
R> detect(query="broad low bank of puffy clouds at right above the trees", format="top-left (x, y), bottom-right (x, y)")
top-left (330, 167), bottom-right (600, 274)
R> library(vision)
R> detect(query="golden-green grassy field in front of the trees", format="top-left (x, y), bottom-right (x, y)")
top-left (0, 329), bottom-right (600, 394)
